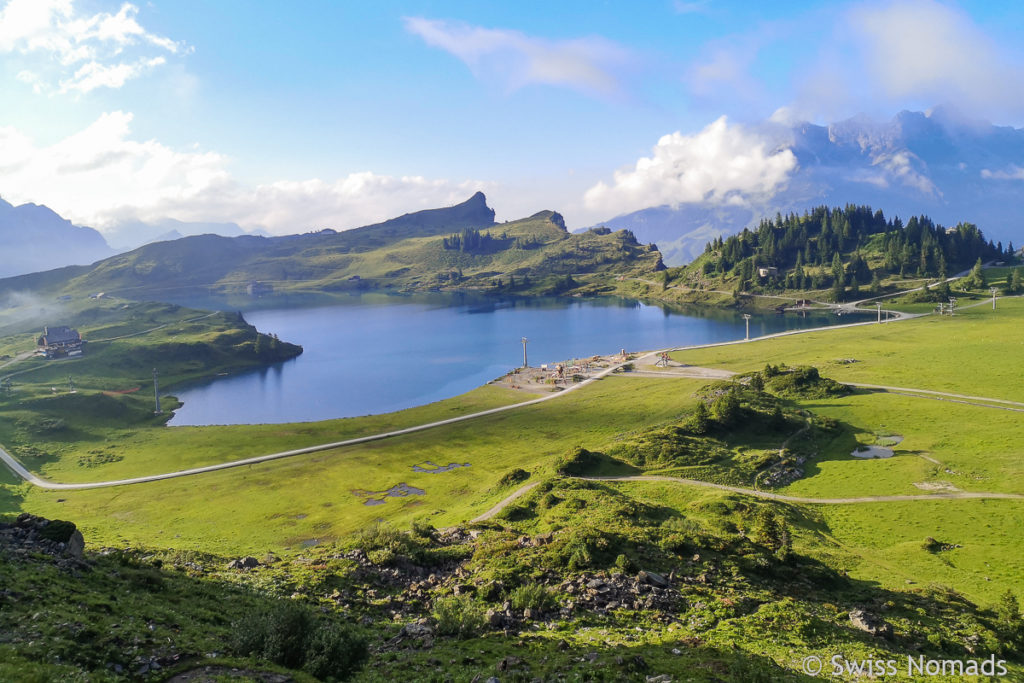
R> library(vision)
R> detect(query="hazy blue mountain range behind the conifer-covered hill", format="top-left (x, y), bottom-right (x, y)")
top-left (599, 109), bottom-right (1024, 264)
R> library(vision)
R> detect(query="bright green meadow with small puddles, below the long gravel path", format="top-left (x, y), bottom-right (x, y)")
top-left (14, 378), bottom-right (699, 552)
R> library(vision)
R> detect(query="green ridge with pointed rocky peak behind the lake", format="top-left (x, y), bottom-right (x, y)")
top-left (0, 193), bottom-right (663, 300)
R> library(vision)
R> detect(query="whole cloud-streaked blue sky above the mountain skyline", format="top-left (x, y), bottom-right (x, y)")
top-left (0, 0), bottom-right (1024, 233)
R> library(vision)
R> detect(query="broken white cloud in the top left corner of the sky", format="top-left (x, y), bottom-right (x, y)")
top-left (0, 0), bottom-right (185, 93)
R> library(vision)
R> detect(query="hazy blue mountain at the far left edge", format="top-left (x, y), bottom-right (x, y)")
top-left (0, 200), bottom-right (114, 278)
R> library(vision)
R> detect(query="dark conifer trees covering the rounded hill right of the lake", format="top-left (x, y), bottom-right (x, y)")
top-left (703, 205), bottom-right (1014, 299)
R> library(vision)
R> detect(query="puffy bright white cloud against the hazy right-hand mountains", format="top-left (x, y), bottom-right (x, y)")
top-left (584, 117), bottom-right (797, 215)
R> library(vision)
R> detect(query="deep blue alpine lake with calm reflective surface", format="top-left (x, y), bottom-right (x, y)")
top-left (170, 294), bottom-right (850, 425)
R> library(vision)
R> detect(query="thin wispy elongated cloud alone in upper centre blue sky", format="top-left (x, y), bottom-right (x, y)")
top-left (404, 16), bottom-right (631, 95)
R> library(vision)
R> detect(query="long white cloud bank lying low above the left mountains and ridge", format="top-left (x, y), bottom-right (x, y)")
top-left (0, 112), bottom-right (489, 233)
